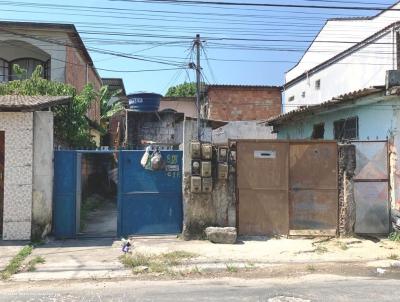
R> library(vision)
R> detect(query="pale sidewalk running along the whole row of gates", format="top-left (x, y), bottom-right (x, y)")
top-left (0, 236), bottom-right (400, 281)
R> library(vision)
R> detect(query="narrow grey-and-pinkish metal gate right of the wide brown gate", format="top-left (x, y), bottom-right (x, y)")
top-left (352, 141), bottom-right (390, 234)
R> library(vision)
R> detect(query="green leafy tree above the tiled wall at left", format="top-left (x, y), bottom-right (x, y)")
top-left (0, 65), bottom-right (98, 148)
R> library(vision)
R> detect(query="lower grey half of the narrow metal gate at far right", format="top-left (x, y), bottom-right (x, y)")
top-left (354, 182), bottom-right (390, 234)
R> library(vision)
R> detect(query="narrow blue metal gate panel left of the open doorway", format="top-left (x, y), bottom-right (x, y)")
top-left (53, 151), bottom-right (77, 238)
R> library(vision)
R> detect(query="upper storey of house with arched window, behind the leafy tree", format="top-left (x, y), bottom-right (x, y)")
top-left (0, 22), bottom-right (102, 145)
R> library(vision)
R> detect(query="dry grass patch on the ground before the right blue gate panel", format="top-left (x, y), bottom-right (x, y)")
top-left (120, 251), bottom-right (198, 273)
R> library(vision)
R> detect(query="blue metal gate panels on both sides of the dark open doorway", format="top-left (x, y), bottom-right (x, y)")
top-left (53, 151), bottom-right (183, 238)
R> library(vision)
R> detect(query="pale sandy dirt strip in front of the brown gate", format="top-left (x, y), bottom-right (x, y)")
top-left (132, 237), bottom-right (400, 263)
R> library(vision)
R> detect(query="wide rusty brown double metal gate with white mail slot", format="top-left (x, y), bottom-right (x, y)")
top-left (237, 140), bottom-right (338, 235)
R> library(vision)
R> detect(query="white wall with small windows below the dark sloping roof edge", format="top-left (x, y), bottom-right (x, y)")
top-left (283, 31), bottom-right (396, 112)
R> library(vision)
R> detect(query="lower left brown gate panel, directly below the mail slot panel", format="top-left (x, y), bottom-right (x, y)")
top-left (238, 189), bottom-right (289, 236)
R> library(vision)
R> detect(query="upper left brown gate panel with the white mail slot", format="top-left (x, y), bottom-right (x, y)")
top-left (237, 141), bottom-right (289, 190)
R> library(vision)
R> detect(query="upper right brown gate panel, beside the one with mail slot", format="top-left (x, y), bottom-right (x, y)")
top-left (289, 142), bottom-right (338, 189)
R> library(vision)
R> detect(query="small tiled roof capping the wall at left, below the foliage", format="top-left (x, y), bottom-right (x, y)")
top-left (0, 95), bottom-right (71, 111)
